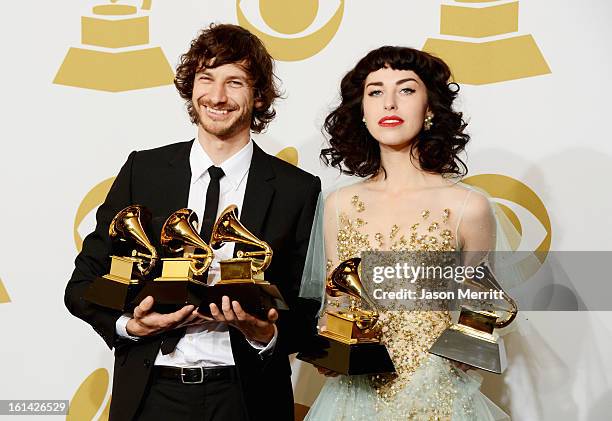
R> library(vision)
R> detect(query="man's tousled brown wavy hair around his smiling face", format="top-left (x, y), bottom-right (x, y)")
top-left (174, 23), bottom-right (280, 133)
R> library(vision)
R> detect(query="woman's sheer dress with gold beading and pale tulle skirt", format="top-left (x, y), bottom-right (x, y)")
top-left (302, 181), bottom-right (509, 421)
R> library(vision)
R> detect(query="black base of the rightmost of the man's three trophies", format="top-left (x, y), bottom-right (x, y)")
top-left (198, 282), bottom-right (289, 320)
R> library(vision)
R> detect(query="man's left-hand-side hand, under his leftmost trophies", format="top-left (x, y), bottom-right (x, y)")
top-left (126, 296), bottom-right (196, 337)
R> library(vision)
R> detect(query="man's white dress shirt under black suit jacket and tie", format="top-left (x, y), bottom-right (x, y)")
top-left (116, 139), bottom-right (278, 367)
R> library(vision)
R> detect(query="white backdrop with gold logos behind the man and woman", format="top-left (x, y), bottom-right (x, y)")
top-left (0, 0), bottom-right (612, 421)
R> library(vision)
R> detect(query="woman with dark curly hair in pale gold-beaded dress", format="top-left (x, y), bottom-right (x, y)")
top-left (302, 46), bottom-right (505, 421)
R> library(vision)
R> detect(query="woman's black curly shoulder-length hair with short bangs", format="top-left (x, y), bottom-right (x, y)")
top-left (321, 46), bottom-right (470, 177)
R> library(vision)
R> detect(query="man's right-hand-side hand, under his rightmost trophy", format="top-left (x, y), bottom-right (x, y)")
top-left (208, 296), bottom-right (278, 344)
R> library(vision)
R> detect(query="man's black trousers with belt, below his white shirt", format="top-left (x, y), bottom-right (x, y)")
top-left (135, 366), bottom-right (248, 421)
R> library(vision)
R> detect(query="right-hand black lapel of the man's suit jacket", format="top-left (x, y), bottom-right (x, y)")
top-left (240, 142), bottom-right (275, 238)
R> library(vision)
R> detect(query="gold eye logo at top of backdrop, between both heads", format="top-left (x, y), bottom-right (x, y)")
top-left (236, 0), bottom-right (344, 61)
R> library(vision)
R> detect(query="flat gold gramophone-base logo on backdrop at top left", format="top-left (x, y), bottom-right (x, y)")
top-left (53, 0), bottom-right (174, 92)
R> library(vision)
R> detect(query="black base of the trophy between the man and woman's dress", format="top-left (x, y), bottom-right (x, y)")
top-left (297, 335), bottom-right (395, 375)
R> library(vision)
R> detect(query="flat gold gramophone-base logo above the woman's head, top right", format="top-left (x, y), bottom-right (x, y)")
top-left (423, 0), bottom-right (550, 85)
